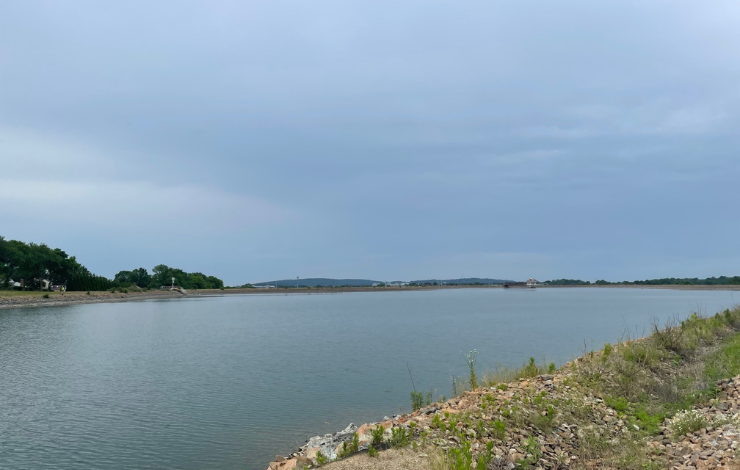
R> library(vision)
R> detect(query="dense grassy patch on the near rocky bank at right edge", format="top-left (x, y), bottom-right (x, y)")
top-left (575, 309), bottom-right (740, 442)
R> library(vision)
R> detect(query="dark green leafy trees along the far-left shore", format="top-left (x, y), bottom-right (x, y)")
top-left (0, 236), bottom-right (224, 291)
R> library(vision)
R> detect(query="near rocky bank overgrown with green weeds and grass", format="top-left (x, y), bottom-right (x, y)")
top-left (271, 309), bottom-right (740, 470)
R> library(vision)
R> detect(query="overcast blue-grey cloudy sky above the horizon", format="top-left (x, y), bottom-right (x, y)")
top-left (0, 0), bottom-right (740, 285)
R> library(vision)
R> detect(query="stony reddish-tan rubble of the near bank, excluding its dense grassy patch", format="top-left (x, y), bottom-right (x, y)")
top-left (268, 367), bottom-right (740, 470)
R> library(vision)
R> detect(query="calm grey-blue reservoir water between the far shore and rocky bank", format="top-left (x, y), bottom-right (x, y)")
top-left (0, 289), bottom-right (733, 470)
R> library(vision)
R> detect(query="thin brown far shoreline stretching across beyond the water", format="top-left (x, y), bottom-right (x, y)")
top-left (0, 285), bottom-right (740, 310)
